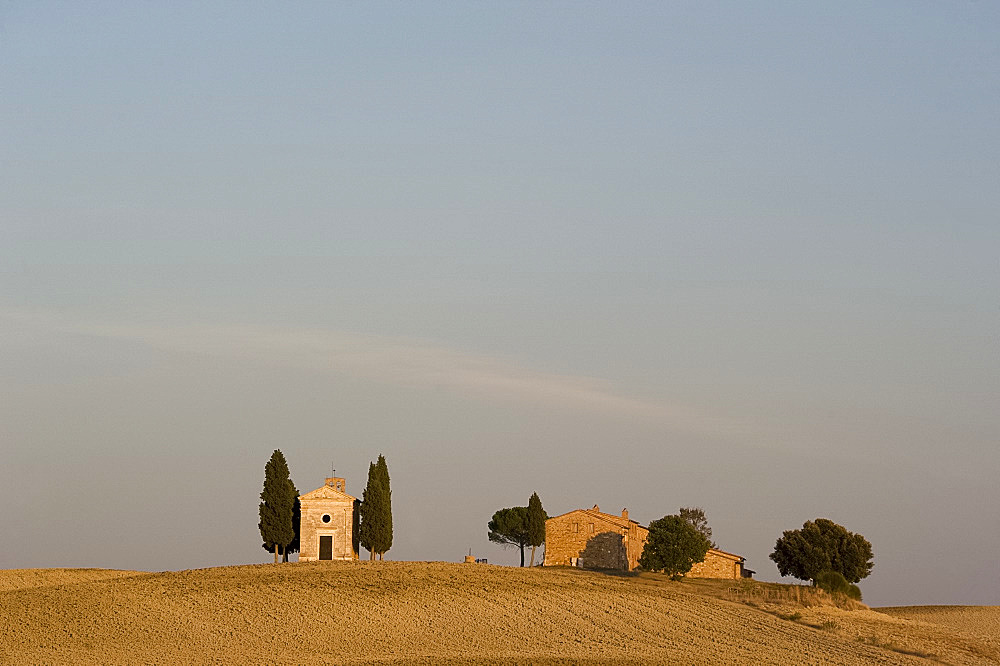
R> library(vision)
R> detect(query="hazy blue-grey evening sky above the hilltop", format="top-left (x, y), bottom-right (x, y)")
top-left (0, 1), bottom-right (1000, 605)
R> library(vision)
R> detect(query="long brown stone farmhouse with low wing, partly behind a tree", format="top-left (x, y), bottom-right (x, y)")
top-left (544, 504), bottom-right (754, 578)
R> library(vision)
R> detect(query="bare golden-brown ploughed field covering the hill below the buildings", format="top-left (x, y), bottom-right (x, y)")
top-left (0, 562), bottom-right (1000, 664)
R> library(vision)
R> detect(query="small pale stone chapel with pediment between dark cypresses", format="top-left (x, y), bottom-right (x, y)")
top-left (299, 477), bottom-right (360, 562)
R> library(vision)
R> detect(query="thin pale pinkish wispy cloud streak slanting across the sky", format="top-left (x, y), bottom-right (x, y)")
top-left (0, 311), bottom-right (738, 434)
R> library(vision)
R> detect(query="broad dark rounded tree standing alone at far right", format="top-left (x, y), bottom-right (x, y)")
top-left (770, 518), bottom-right (875, 583)
